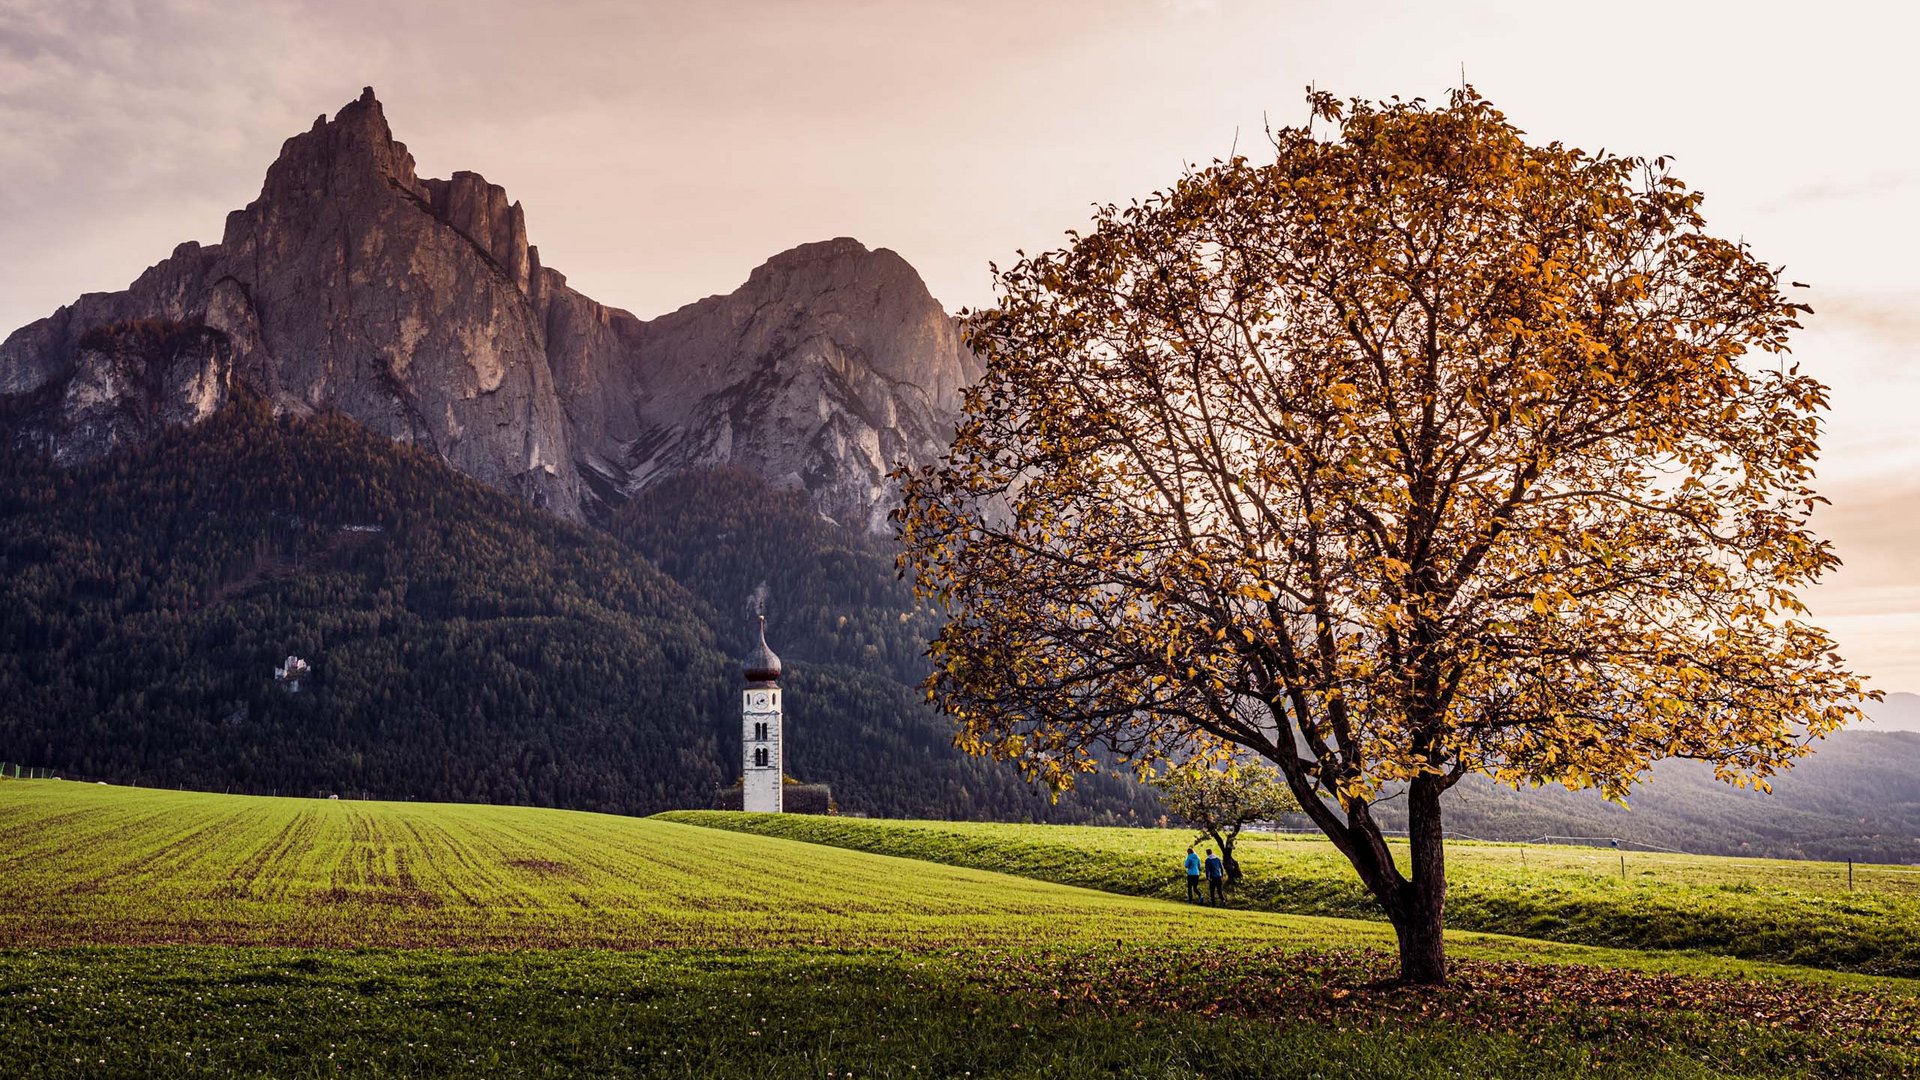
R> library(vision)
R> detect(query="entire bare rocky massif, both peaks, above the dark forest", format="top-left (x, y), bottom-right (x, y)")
top-left (0, 88), bottom-right (979, 528)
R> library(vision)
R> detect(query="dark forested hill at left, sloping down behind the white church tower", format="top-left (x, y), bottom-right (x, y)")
top-left (0, 390), bottom-right (1152, 821)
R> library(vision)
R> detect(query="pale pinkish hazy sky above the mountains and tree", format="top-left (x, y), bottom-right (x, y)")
top-left (0, 0), bottom-right (1920, 690)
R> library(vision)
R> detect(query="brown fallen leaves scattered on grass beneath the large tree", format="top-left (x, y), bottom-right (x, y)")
top-left (975, 945), bottom-right (1920, 1065)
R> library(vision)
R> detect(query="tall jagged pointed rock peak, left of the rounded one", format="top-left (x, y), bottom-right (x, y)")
top-left (0, 88), bottom-right (580, 515)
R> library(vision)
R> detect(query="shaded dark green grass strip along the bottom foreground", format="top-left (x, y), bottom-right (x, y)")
top-left (0, 947), bottom-right (1873, 1080)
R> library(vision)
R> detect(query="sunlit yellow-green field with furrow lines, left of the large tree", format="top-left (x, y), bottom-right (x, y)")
top-left (0, 780), bottom-right (1320, 949)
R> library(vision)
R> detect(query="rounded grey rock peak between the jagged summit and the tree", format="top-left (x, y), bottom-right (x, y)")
top-left (549, 238), bottom-right (979, 528)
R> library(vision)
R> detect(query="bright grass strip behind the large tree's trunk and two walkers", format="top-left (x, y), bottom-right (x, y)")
top-left (662, 811), bottom-right (1920, 978)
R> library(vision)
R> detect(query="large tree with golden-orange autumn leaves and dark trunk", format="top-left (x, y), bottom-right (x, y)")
top-left (899, 88), bottom-right (1860, 982)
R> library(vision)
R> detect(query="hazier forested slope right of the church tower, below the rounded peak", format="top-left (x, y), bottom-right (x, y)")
top-left (609, 469), bottom-right (1160, 824)
